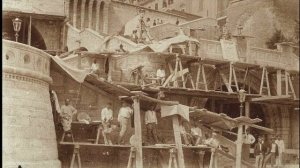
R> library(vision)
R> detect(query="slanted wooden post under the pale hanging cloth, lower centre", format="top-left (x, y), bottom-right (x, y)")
top-left (172, 115), bottom-right (185, 168)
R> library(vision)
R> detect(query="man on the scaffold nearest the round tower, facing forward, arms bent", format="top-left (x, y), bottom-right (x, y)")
top-left (60, 99), bottom-right (77, 135)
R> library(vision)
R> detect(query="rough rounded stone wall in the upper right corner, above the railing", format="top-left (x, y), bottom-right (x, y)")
top-left (226, 0), bottom-right (297, 48)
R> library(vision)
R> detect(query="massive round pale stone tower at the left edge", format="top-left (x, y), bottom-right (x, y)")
top-left (2, 40), bottom-right (61, 168)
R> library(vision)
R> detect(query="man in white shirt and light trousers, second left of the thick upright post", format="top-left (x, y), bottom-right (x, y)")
top-left (101, 103), bottom-right (113, 145)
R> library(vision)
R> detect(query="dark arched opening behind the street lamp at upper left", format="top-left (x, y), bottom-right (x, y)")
top-left (2, 17), bottom-right (47, 50)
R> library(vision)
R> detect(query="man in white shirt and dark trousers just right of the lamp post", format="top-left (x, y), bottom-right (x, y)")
top-left (242, 128), bottom-right (255, 161)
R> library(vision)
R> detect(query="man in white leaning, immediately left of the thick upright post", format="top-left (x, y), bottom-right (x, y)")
top-left (118, 102), bottom-right (133, 144)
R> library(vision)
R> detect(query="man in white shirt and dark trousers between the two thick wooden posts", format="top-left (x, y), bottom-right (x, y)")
top-left (145, 107), bottom-right (159, 144)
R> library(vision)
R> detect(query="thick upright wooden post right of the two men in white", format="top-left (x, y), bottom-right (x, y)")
top-left (133, 96), bottom-right (143, 168)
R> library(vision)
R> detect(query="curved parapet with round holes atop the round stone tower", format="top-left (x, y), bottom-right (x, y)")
top-left (2, 40), bottom-right (52, 83)
